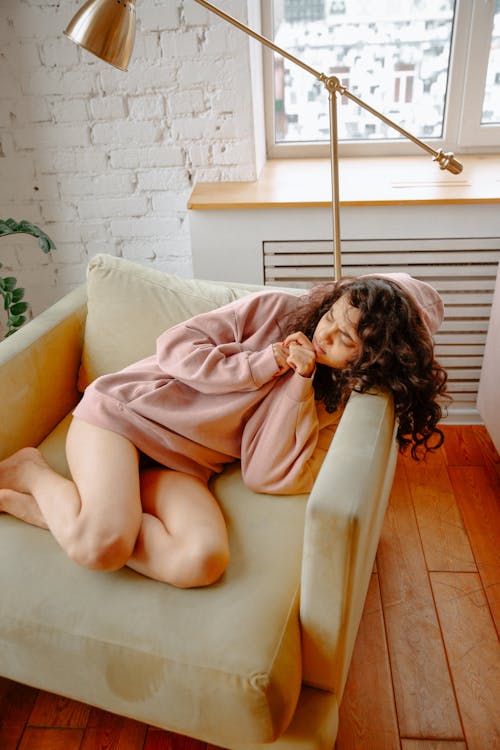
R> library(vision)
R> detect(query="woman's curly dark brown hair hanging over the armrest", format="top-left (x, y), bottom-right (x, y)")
top-left (286, 277), bottom-right (448, 460)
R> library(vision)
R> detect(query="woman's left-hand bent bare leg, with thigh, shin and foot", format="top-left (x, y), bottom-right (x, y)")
top-left (0, 419), bottom-right (142, 570)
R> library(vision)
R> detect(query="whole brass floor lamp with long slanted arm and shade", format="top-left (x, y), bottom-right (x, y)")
top-left (64, 0), bottom-right (462, 279)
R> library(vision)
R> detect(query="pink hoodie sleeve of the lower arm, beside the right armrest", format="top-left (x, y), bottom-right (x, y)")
top-left (241, 372), bottom-right (323, 495)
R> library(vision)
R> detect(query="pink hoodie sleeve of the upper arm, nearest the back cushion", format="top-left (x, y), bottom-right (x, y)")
top-left (156, 293), bottom-right (290, 394)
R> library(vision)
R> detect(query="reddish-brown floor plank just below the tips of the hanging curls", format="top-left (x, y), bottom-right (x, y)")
top-left (405, 462), bottom-right (477, 571)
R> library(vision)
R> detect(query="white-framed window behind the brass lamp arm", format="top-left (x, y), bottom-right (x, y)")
top-left (262, 0), bottom-right (500, 157)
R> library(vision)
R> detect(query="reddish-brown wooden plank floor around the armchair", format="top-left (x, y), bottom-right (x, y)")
top-left (0, 426), bottom-right (500, 750)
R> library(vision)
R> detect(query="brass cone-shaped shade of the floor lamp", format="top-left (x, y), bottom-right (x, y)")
top-left (64, 0), bottom-right (135, 70)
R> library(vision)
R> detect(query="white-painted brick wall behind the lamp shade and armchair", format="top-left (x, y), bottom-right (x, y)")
top-left (0, 0), bottom-right (258, 314)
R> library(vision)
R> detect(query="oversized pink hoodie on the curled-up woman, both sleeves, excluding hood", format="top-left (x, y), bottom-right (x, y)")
top-left (74, 292), bottom-right (332, 494)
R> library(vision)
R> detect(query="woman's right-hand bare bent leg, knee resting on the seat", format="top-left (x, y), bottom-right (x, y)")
top-left (127, 469), bottom-right (229, 588)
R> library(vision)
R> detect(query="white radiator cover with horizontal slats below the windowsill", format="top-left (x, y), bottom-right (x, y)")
top-left (263, 237), bottom-right (500, 424)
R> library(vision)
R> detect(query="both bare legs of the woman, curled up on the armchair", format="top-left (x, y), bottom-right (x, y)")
top-left (0, 419), bottom-right (229, 588)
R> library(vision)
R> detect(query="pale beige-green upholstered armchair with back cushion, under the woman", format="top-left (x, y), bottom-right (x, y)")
top-left (0, 256), bottom-right (396, 750)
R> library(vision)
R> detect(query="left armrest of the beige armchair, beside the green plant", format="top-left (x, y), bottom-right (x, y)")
top-left (0, 287), bottom-right (86, 458)
